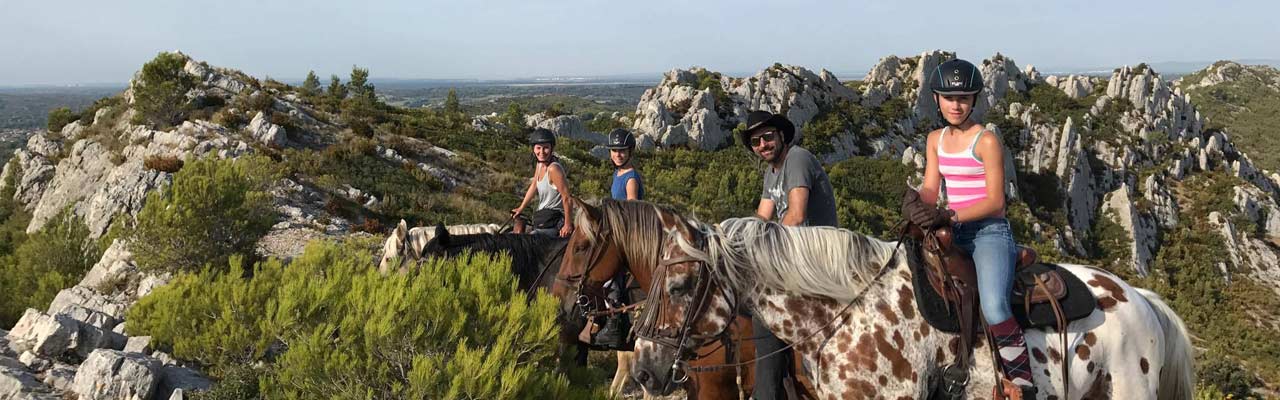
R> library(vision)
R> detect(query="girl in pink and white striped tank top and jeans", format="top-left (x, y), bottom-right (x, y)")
top-left (920, 59), bottom-right (1036, 399)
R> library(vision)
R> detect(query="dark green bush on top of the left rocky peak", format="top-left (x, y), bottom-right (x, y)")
top-left (133, 53), bottom-right (196, 127)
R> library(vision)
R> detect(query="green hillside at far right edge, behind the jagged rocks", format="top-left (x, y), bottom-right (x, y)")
top-left (1175, 62), bottom-right (1280, 171)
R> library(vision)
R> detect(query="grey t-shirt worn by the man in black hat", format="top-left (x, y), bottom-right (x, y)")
top-left (760, 146), bottom-right (838, 227)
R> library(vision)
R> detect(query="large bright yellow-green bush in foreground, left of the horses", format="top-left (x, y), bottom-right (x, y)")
top-left (128, 242), bottom-right (580, 399)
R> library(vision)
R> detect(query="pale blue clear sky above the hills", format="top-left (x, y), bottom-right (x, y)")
top-left (0, 0), bottom-right (1280, 85)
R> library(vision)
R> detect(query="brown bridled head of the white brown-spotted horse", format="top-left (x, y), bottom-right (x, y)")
top-left (632, 219), bottom-right (739, 395)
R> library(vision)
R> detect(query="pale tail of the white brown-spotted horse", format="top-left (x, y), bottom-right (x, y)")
top-left (1135, 287), bottom-right (1196, 400)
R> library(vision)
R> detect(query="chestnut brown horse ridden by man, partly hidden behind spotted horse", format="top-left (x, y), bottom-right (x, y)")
top-left (554, 199), bottom-right (803, 399)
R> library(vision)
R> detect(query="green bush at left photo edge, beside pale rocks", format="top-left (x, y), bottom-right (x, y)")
top-left (0, 210), bottom-right (102, 327)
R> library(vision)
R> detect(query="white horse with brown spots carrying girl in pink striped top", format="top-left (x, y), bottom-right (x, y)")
top-left (634, 218), bottom-right (1194, 399)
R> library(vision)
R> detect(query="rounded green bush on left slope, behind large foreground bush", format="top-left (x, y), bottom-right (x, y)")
top-left (128, 158), bottom-right (278, 271)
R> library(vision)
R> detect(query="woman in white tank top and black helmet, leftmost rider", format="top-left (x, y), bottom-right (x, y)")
top-left (511, 128), bottom-right (573, 237)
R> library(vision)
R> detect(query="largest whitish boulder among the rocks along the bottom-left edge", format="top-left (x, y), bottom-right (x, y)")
top-left (72, 350), bottom-right (161, 400)
